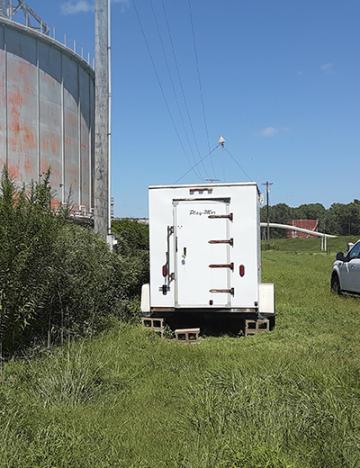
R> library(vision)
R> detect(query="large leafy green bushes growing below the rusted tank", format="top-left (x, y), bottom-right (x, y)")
top-left (0, 171), bottom-right (143, 356)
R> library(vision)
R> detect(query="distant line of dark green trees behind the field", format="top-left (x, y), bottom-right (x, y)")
top-left (261, 200), bottom-right (360, 237)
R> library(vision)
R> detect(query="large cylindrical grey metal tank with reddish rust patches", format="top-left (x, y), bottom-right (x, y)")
top-left (0, 15), bottom-right (95, 214)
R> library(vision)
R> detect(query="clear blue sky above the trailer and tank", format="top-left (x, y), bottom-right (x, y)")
top-left (29, 0), bottom-right (360, 217)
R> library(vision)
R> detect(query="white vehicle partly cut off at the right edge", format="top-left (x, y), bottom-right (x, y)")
top-left (331, 240), bottom-right (360, 294)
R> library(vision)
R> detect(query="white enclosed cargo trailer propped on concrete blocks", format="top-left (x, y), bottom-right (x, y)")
top-left (141, 183), bottom-right (275, 332)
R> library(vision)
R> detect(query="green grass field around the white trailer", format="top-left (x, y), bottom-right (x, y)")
top-left (0, 238), bottom-right (360, 468)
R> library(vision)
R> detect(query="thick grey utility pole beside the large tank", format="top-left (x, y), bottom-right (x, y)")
top-left (94, 0), bottom-right (111, 245)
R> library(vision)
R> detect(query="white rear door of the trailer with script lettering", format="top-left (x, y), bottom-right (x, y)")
top-left (174, 200), bottom-right (232, 308)
